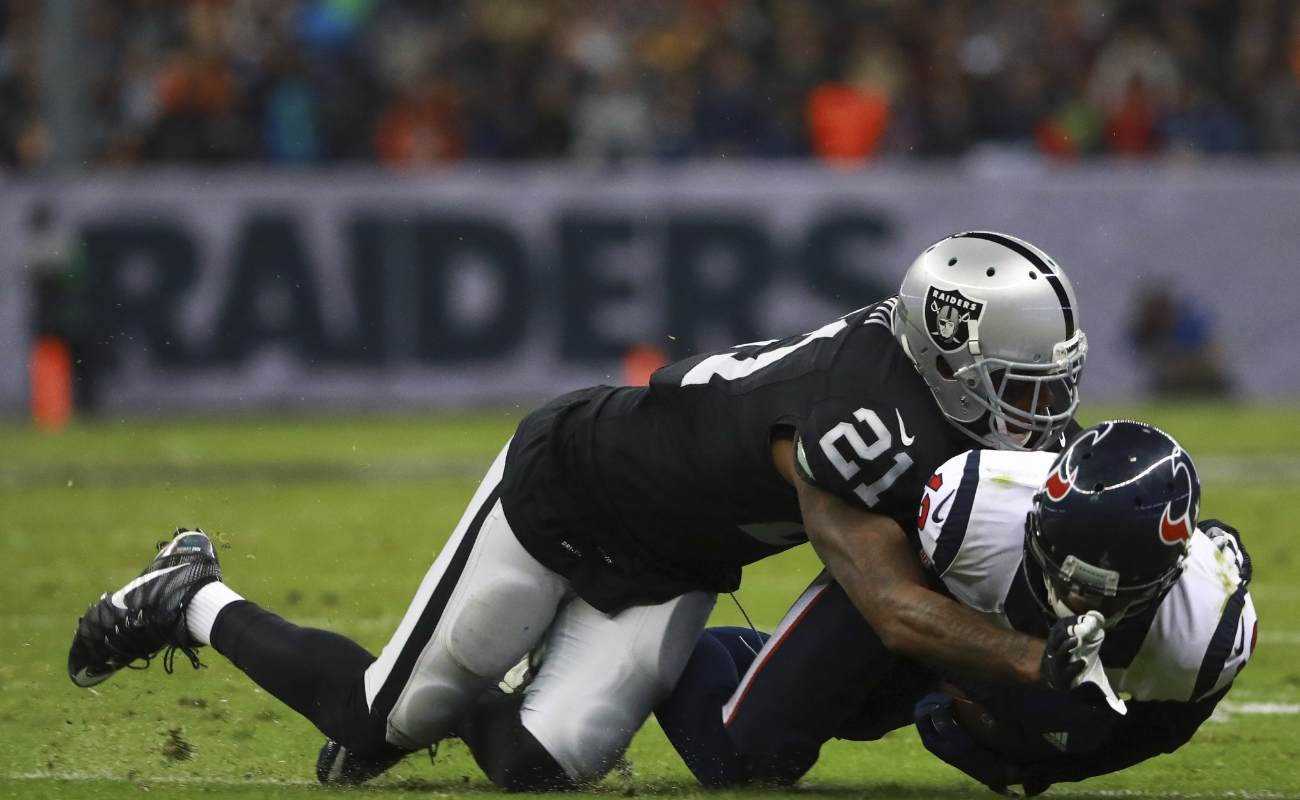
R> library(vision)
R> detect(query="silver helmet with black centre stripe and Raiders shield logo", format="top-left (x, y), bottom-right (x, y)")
top-left (893, 230), bottom-right (1088, 450)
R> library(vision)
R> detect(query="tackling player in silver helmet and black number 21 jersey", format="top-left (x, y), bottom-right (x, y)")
top-left (69, 232), bottom-right (1087, 790)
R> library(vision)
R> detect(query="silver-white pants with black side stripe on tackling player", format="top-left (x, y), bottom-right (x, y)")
top-left (365, 450), bottom-right (715, 782)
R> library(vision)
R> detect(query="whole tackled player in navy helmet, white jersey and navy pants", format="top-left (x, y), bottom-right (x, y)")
top-left (657, 421), bottom-right (1258, 793)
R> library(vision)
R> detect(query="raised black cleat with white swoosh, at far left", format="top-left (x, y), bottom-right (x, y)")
top-left (68, 528), bottom-right (221, 687)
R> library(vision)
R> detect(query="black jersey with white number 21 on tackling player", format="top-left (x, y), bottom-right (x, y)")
top-left (501, 299), bottom-right (970, 611)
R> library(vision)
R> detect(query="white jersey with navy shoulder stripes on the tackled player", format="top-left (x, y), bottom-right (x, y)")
top-left (917, 450), bottom-right (1258, 701)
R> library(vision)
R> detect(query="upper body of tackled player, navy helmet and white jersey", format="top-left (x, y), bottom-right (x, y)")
top-left (915, 421), bottom-right (1258, 793)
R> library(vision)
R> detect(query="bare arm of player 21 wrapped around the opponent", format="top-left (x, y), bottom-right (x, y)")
top-left (772, 438), bottom-right (1043, 683)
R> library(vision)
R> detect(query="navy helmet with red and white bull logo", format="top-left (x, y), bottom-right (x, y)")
top-left (1024, 420), bottom-right (1201, 627)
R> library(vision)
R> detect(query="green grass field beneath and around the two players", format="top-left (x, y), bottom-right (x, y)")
top-left (0, 407), bottom-right (1300, 797)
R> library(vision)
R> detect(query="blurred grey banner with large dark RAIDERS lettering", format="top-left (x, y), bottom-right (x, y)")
top-left (0, 163), bottom-right (1300, 415)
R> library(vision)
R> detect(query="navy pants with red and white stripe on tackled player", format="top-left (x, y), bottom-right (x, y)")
top-left (655, 572), bottom-right (936, 787)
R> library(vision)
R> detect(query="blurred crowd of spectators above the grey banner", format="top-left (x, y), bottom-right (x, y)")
top-left (0, 0), bottom-right (1300, 169)
